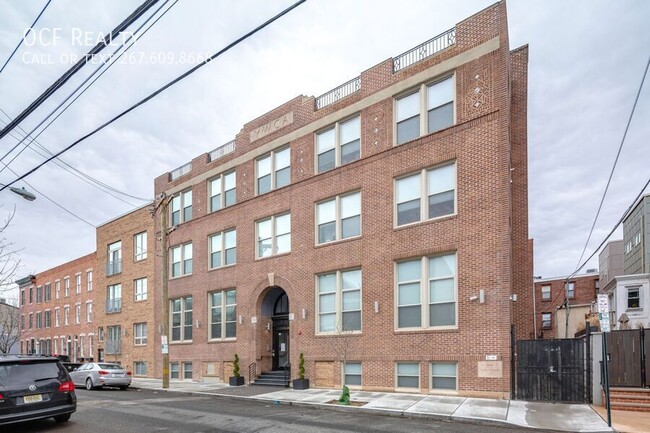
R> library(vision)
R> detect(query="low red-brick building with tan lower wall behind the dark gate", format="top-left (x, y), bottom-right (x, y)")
top-left (535, 270), bottom-right (600, 339)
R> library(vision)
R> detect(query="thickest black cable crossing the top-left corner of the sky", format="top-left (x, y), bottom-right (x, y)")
top-left (0, 0), bottom-right (158, 139)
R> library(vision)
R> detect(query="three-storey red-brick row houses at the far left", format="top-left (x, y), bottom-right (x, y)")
top-left (16, 253), bottom-right (97, 362)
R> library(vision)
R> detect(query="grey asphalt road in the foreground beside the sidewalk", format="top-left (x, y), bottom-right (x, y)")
top-left (10, 389), bottom-right (556, 433)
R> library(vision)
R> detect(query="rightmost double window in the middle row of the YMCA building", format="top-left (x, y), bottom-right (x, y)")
top-left (395, 163), bottom-right (456, 226)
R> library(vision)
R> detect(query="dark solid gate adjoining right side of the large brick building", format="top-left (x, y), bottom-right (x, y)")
top-left (517, 338), bottom-right (589, 403)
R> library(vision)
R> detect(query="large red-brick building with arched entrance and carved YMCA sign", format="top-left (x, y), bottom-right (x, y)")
top-left (153, 2), bottom-right (533, 396)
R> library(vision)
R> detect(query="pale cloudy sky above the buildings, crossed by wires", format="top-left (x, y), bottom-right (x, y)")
top-left (0, 0), bottom-right (650, 304)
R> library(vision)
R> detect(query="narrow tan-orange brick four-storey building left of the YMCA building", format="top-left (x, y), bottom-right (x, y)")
top-left (96, 204), bottom-right (160, 376)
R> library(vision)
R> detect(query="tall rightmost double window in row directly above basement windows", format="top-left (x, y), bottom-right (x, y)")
top-left (396, 254), bottom-right (456, 328)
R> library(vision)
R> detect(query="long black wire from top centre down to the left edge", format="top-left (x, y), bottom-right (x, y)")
top-left (0, 0), bottom-right (307, 191)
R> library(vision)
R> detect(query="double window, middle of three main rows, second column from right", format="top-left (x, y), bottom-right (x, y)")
top-left (316, 192), bottom-right (361, 244)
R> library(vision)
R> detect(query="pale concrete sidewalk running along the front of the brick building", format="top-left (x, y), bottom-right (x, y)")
top-left (132, 378), bottom-right (614, 432)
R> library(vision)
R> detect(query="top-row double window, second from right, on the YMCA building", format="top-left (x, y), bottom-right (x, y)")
top-left (316, 116), bottom-right (361, 173)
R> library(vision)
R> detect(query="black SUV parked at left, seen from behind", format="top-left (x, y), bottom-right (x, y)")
top-left (0, 355), bottom-right (77, 425)
